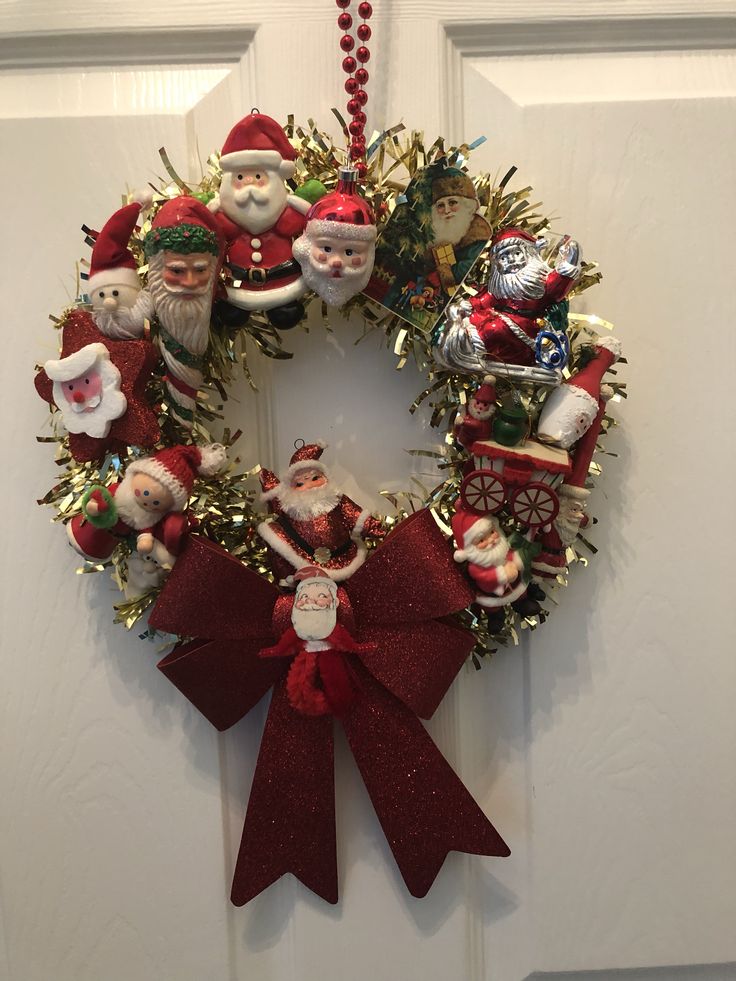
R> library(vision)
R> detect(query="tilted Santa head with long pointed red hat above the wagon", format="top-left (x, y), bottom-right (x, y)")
top-left (537, 337), bottom-right (622, 450)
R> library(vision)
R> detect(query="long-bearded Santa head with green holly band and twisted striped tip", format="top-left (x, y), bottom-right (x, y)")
top-left (145, 195), bottom-right (223, 429)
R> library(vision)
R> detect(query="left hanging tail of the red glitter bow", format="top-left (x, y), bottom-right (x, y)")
top-left (231, 680), bottom-right (337, 906)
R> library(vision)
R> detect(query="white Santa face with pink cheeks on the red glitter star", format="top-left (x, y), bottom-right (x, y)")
top-left (44, 344), bottom-right (128, 439)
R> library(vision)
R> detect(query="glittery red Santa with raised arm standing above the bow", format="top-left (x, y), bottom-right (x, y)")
top-left (258, 443), bottom-right (384, 584)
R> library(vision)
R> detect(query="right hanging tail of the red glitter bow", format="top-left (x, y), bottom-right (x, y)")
top-left (341, 664), bottom-right (510, 897)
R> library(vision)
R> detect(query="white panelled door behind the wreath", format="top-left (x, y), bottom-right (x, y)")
top-left (0, 0), bottom-right (736, 981)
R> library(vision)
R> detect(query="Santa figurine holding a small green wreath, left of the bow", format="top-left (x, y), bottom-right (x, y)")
top-left (66, 443), bottom-right (226, 565)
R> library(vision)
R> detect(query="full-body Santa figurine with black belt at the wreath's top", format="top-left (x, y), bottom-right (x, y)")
top-left (209, 110), bottom-right (310, 330)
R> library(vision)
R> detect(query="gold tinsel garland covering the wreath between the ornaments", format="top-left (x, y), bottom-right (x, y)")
top-left (33, 120), bottom-right (626, 666)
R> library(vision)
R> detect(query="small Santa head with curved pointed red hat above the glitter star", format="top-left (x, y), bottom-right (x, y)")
top-left (87, 200), bottom-right (153, 341)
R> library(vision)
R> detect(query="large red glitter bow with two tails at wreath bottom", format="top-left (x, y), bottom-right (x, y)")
top-left (150, 511), bottom-right (509, 906)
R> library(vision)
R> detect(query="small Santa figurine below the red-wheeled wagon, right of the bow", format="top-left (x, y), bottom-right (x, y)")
top-left (452, 508), bottom-right (541, 629)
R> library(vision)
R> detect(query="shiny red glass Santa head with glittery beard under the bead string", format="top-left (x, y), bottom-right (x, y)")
top-left (293, 167), bottom-right (376, 307)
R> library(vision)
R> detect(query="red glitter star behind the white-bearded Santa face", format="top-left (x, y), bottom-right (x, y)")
top-left (35, 310), bottom-right (160, 463)
